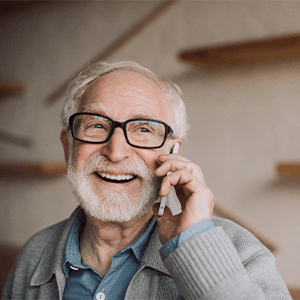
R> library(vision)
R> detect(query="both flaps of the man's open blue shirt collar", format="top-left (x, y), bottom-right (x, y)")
top-left (63, 210), bottom-right (156, 278)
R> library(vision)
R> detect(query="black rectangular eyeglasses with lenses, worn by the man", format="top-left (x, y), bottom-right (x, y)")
top-left (69, 113), bottom-right (173, 149)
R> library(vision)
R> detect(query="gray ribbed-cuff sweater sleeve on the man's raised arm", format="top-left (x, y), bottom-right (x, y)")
top-left (164, 226), bottom-right (291, 300)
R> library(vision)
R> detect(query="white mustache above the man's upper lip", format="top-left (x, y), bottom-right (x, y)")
top-left (83, 153), bottom-right (154, 178)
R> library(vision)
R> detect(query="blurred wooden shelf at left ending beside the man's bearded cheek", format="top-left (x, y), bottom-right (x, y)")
top-left (0, 162), bottom-right (67, 178)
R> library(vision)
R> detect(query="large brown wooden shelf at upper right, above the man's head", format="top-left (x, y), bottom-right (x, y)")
top-left (179, 35), bottom-right (300, 67)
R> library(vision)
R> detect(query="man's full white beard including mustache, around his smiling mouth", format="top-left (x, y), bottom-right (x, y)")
top-left (67, 153), bottom-right (162, 223)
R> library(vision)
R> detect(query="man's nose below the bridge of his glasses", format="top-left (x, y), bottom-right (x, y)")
top-left (101, 127), bottom-right (132, 162)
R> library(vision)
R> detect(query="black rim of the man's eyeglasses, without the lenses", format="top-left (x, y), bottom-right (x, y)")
top-left (69, 112), bottom-right (173, 149)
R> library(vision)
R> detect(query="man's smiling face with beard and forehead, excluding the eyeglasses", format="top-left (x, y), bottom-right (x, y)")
top-left (64, 71), bottom-right (175, 222)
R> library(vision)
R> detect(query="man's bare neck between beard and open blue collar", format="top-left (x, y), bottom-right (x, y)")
top-left (80, 210), bottom-right (153, 277)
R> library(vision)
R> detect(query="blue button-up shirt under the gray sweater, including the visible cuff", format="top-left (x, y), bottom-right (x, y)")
top-left (63, 211), bottom-right (214, 300)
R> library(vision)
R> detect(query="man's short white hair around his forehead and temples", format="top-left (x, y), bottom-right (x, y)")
top-left (61, 61), bottom-right (188, 139)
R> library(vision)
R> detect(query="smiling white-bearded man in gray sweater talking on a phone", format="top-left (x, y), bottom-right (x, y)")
top-left (3, 62), bottom-right (291, 300)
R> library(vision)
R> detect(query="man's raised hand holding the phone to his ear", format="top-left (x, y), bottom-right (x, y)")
top-left (153, 154), bottom-right (214, 244)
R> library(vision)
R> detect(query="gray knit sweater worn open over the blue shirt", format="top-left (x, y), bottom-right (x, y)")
top-left (2, 208), bottom-right (291, 300)
